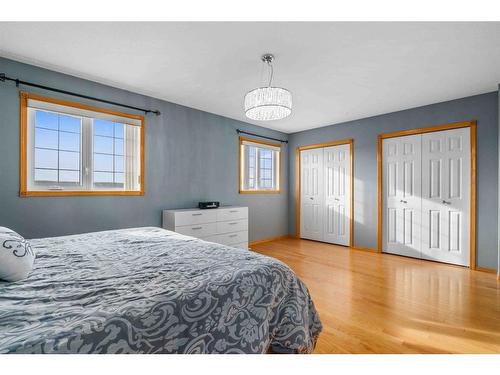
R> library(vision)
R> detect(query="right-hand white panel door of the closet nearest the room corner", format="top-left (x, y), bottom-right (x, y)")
top-left (323, 144), bottom-right (351, 246)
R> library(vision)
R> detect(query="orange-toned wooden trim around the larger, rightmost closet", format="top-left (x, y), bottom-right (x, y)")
top-left (377, 120), bottom-right (477, 270)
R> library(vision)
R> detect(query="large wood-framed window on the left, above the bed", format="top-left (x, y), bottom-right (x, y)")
top-left (21, 93), bottom-right (144, 196)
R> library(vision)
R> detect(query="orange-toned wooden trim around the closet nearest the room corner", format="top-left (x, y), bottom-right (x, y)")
top-left (295, 138), bottom-right (354, 247)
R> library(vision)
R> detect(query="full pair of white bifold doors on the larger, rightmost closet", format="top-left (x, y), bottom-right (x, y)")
top-left (382, 128), bottom-right (471, 266)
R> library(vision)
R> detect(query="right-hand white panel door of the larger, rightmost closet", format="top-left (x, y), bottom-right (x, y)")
top-left (422, 128), bottom-right (471, 266)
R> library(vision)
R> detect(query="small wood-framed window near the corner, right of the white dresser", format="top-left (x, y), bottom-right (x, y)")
top-left (240, 137), bottom-right (281, 193)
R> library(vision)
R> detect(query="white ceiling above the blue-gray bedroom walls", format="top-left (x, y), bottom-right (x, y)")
top-left (0, 22), bottom-right (500, 133)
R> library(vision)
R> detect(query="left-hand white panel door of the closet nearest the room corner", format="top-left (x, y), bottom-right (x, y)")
top-left (300, 148), bottom-right (325, 241)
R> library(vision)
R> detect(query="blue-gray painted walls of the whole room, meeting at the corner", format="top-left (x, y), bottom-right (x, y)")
top-left (0, 58), bottom-right (499, 268)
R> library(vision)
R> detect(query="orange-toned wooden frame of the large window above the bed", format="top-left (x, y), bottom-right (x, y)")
top-left (19, 91), bottom-right (145, 197)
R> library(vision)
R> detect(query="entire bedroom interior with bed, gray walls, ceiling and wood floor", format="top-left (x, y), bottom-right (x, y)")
top-left (0, 0), bottom-right (500, 374)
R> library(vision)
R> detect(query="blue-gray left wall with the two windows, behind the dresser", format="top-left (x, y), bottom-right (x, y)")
top-left (0, 58), bottom-right (288, 240)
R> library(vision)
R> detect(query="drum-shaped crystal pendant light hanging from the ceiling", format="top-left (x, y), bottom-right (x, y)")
top-left (245, 54), bottom-right (292, 121)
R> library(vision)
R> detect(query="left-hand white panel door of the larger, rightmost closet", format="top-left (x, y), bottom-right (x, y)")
top-left (382, 135), bottom-right (422, 258)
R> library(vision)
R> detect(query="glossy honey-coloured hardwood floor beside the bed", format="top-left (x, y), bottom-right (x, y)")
top-left (252, 238), bottom-right (500, 353)
